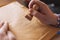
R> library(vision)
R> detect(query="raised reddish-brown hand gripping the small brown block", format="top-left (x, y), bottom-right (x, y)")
top-left (29, 0), bottom-right (57, 25)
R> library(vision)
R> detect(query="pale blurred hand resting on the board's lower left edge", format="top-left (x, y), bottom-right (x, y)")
top-left (0, 22), bottom-right (16, 40)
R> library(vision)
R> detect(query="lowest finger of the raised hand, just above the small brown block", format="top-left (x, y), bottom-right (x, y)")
top-left (31, 10), bottom-right (46, 24)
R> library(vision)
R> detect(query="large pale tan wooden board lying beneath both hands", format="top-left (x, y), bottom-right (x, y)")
top-left (0, 1), bottom-right (58, 40)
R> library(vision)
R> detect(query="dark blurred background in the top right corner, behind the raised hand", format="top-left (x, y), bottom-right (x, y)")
top-left (41, 0), bottom-right (60, 14)
